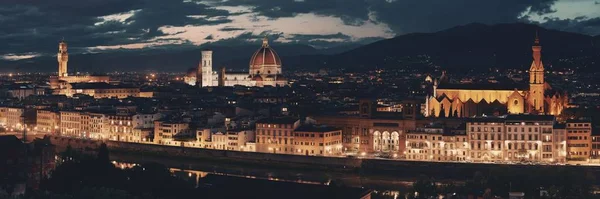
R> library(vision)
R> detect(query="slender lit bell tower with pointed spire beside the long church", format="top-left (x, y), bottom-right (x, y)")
top-left (528, 32), bottom-right (544, 113)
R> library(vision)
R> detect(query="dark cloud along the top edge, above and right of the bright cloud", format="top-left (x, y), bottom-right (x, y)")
top-left (210, 0), bottom-right (556, 34)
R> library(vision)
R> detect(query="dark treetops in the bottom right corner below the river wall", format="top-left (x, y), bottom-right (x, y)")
top-left (408, 167), bottom-right (600, 199)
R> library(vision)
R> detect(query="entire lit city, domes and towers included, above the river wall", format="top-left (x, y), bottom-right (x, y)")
top-left (0, 32), bottom-right (600, 166)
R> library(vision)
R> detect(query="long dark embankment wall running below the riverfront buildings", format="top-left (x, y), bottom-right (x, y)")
top-left (50, 137), bottom-right (600, 180)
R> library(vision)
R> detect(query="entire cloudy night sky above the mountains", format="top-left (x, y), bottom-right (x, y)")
top-left (0, 0), bottom-right (600, 60)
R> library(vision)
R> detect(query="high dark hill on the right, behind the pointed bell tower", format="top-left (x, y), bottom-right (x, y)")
top-left (330, 23), bottom-right (600, 70)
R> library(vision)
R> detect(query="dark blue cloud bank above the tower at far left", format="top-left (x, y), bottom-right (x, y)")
top-left (0, 0), bottom-right (230, 54)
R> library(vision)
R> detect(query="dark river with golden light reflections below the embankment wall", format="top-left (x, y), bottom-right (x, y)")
top-left (111, 154), bottom-right (452, 195)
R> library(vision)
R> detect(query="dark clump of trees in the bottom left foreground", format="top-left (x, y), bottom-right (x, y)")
top-left (24, 144), bottom-right (196, 199)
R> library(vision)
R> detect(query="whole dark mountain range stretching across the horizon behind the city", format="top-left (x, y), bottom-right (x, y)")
top-left (0, 23), bottom-right (600, 72)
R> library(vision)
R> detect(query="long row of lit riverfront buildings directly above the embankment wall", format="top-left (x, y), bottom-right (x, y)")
top-left (0, 100), bottom-right (600, 163)
